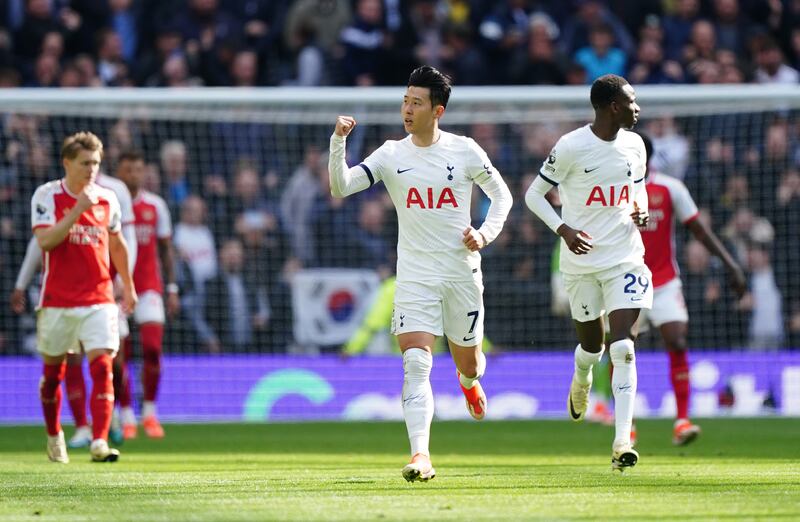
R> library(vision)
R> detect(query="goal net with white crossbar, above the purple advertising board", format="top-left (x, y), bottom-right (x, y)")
top-left (0, 85), bottom-right (800, 418)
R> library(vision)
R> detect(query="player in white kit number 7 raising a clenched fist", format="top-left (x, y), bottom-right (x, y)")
top-left (328, 66), bottom-right (512, 482)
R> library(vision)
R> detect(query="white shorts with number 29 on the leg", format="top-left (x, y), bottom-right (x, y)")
top-left (564, 263), bottom-right (653, 322)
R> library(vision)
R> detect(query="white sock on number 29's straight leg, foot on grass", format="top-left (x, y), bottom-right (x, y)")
top-left (609, 339), bottom-right (636, 447)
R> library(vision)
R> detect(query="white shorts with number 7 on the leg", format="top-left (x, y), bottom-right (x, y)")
top-left (392, 275), bottom-right (484, 346)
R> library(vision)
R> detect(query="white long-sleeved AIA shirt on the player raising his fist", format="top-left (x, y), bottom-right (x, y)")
top-left (331, 131), bottom-right (512, 281)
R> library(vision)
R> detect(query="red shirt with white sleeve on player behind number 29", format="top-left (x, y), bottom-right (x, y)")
top-left (642, 173), bottom-right (698, 288)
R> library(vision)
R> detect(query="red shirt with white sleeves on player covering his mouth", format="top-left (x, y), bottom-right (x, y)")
top-left (31, 180), bottom-right (121, 308)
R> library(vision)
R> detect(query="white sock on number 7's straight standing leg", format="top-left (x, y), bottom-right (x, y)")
top-left (403, 348), bottom-right (433, 456)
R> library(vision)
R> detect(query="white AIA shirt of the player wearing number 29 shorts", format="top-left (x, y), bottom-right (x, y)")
top-left (539, 125), bottom-right (648, 274)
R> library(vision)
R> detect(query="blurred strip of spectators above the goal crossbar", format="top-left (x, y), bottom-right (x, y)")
top-left (0, 0), bottom-right (800, 87)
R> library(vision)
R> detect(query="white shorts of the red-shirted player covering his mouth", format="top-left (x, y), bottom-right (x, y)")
top-left (36, 303), bottom-right (119, 357)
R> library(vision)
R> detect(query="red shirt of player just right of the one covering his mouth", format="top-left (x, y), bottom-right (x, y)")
top-left (133, 190), bottom-right (172, 294)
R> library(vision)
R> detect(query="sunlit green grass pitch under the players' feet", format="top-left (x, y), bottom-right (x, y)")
top-left (0, 419), bottom-right (800, 521)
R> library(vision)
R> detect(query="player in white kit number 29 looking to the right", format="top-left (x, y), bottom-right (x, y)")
top-left (525, 74), bottom-right (653, 471)
